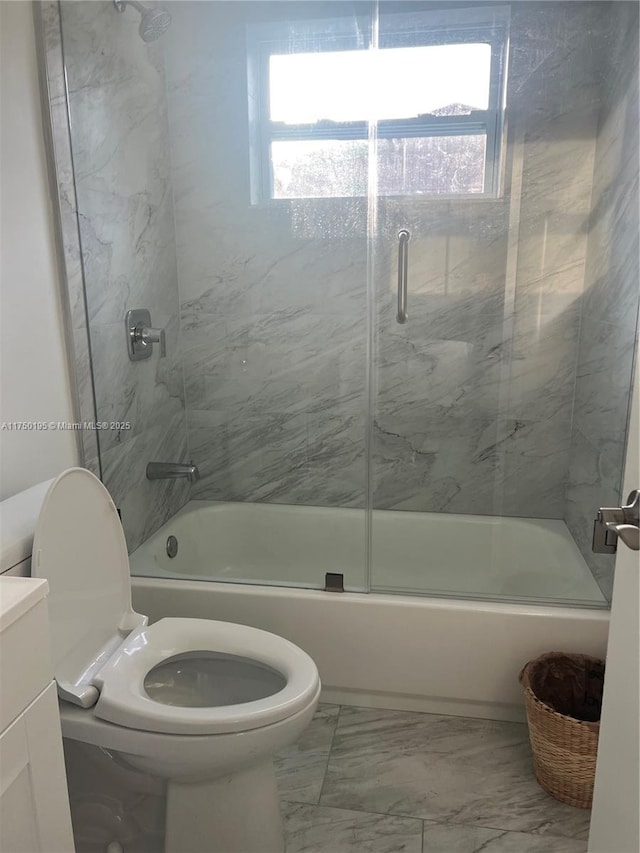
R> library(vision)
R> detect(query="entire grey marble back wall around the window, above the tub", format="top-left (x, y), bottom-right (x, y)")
top-left (167, 3), bottom-right (607, 518)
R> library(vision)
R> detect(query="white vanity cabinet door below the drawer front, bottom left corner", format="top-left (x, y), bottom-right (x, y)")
top-left (0, 683), bottom-right (74, 853)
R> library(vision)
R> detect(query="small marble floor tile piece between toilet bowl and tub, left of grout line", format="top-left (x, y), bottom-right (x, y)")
top-left (275, 704), bottom-right (340, 803)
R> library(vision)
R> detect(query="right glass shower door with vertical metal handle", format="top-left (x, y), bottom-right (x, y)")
top-left (370, 2), bottom-right (631, 606)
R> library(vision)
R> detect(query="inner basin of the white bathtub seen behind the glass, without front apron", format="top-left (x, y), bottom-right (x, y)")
top-left (132, 501), bottom-right (606, 607)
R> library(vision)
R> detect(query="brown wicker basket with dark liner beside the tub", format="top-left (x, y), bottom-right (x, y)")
top-left (520, 652), bottom-right (604, 809)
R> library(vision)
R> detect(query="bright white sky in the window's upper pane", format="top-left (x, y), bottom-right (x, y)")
top-left (269, 43), bottom-right (491, 124)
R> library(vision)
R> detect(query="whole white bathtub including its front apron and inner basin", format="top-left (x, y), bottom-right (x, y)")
top-left (131, 501), bottom-right (609, 721)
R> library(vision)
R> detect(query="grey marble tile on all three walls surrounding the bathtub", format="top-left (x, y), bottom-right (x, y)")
top-left (42, 2), bottom-right (637, 575)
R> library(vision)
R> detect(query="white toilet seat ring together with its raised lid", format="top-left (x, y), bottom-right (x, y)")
top-left (32, 468), bottom-right (320, 735)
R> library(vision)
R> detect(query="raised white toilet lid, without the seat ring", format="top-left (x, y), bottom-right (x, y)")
top-left (31, 468), bottom-right (147, 708)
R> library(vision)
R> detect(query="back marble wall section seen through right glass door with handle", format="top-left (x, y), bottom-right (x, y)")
top-left (373, 3), bottom-right (604, 518)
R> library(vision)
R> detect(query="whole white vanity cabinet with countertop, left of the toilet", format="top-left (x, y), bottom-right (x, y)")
top-left (0, 577), bottom-right (74, 853)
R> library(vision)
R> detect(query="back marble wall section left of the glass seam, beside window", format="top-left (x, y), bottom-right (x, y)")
top-left (167, 2), bottom-right (367, 506)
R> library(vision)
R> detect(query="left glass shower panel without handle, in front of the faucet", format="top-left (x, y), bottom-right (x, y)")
top-left (56, 0), bottom-right (373, 591)
